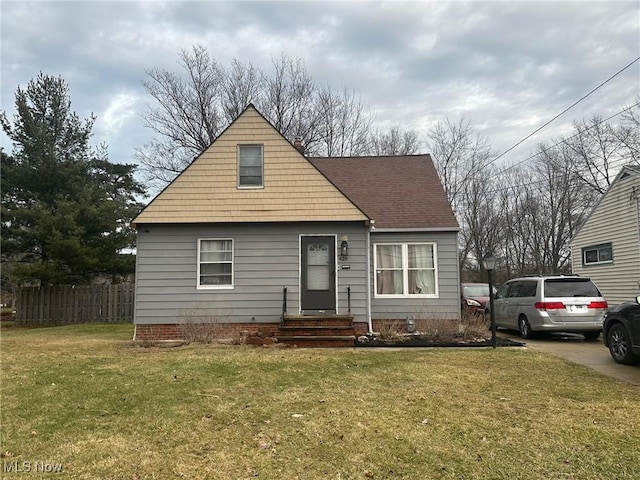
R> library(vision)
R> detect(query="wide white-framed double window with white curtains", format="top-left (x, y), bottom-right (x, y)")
top-left (374, 243), bottom-right (438, 297)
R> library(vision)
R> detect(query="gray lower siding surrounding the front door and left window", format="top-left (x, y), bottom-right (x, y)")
top-left (135, 222), bottom-right (366, 324)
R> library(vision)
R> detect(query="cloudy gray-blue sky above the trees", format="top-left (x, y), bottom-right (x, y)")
top-left (0, 0), bottom-right (640, 176)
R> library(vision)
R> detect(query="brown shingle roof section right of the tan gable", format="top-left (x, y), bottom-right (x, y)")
top-left (309, 155), bottom-right (458, 230)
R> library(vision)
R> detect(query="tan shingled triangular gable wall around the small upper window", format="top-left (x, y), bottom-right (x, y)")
top-left (131, 105), bottom-right (368, 225)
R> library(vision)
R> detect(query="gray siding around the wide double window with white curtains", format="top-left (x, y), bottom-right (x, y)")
top-left (371, 232), bottom-right (460, 319)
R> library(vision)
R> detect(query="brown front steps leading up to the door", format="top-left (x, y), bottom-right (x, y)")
top-left (277, 314), bottom-right (356, 347)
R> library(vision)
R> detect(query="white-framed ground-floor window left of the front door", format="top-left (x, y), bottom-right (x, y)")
top-left (198, 238), bottom-right (233, 288)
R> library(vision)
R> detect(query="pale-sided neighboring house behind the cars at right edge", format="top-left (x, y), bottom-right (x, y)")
top-left (571, 166), bottom-right (640, 305)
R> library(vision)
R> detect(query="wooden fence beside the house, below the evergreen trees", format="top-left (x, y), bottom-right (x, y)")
top-left (14, 283), bottom-right (134, 325)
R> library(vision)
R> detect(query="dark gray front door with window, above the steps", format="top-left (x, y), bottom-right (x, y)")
top-left (300, 236), bottom-right (336, 313)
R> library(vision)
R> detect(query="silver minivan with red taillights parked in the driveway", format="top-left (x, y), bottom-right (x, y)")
top-left (494, 276), bottom-right (607, 340)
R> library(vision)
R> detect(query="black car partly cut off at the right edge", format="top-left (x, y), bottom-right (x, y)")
top-left (602, 296), bottom-right (640, 365)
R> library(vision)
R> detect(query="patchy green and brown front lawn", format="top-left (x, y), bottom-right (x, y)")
top-left (0, 325), bottom-right (640, 480)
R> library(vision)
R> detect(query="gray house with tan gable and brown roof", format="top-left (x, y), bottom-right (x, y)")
top-left (132, 105), bottom-right (460, 345)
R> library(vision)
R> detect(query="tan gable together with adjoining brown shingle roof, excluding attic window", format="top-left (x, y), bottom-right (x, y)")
top-left (131, 105), bottom-right (458, 231)
